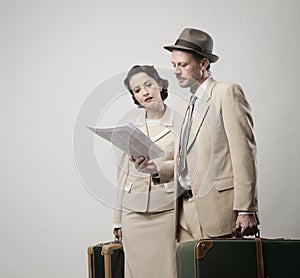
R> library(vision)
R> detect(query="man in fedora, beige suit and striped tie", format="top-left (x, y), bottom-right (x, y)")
top-left (160, 28), bottom-right (259, 242)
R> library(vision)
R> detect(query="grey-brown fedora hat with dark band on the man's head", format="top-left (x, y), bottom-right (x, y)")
top-left (164, 28), bottom-right (219, 63)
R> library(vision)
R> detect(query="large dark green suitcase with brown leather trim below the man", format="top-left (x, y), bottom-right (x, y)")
top-left (176, 238), bottom-right (300, 278)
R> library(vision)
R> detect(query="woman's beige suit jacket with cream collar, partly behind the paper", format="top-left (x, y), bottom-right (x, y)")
top-left (113, 107), bottom-right (181, 224)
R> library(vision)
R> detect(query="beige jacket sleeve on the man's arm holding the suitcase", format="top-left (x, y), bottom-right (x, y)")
top-left (222, 84), bottom-right (257, 211)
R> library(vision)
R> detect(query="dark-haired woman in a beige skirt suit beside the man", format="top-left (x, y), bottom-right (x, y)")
top-left (114, 66), bottom-right (180, 278)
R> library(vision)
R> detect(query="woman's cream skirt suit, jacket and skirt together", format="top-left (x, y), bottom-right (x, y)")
top-left (113, 107), bottom-right (180, 278)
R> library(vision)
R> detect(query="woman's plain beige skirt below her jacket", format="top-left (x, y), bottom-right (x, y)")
top-left (122, 210), bottom-right (177, 278)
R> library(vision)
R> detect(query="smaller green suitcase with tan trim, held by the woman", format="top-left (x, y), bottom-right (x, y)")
top-left (87, 241), bottom-right (124, 278)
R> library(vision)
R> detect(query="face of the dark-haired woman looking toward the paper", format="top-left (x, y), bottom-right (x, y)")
top-left (129, 72), bottom-right (163, 109)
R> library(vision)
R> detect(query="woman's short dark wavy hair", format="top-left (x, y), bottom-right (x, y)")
top-left (124, 65), bottom-right (169, 105)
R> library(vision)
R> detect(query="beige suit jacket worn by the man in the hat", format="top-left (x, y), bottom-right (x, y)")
top-left (175, 78), bottom-right (257, 237)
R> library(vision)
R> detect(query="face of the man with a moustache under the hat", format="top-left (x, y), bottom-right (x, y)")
top-left (172, 50), bottom-right (203, 88)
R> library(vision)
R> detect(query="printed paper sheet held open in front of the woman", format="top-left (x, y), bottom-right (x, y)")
top-left (87, 123), bottom-right (164, 159)
